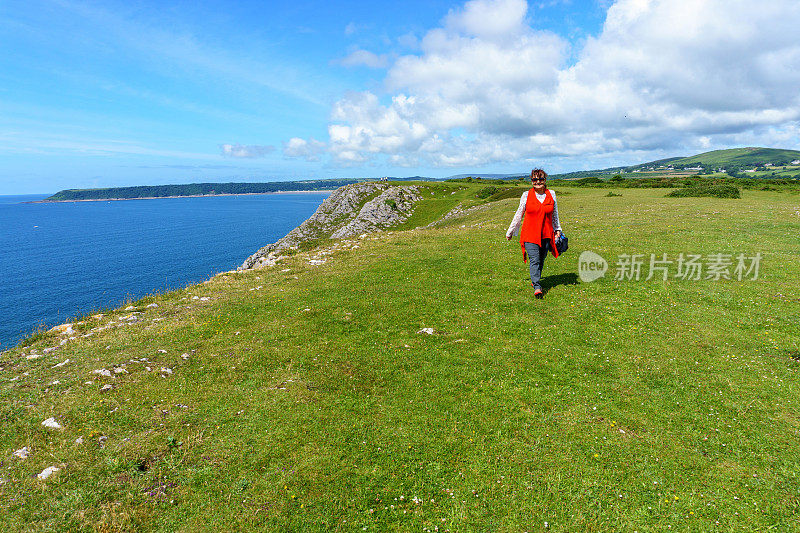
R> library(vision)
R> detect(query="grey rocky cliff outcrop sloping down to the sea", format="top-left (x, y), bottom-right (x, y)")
top-left (239, 183), bottom-right (420, 270)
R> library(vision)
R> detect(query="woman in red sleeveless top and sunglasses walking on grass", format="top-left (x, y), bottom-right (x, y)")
top-left (506, 168), bottom-right (561, 298)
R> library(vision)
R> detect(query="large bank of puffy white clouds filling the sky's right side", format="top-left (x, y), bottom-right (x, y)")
top-left (316, 0), bottom-right (800, 166)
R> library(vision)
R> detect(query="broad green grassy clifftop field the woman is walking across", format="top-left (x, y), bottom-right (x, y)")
top-left (0, 184), bottom-right (800, 531)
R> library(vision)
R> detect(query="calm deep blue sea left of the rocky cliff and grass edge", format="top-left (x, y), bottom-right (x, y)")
top-left (0, 192), bottom-right (330, 351)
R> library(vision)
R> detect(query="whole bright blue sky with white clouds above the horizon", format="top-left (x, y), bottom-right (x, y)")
top-left (0, 0), bottom-right (800, 194)
